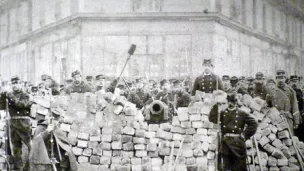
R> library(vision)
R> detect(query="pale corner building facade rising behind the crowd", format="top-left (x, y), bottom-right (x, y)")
top-left (0, 0), bottom-right (304, 83)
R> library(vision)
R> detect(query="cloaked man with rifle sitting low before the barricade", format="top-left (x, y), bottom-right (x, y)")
top-left (29, 117), bottom-right (77, 171)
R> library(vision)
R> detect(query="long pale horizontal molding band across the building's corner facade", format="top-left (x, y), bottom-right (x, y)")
top-left (0, 12), bottom-right (304, 51)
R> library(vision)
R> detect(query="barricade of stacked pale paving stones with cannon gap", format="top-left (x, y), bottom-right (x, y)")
top-left (0, 93), bottom-right (304, 171)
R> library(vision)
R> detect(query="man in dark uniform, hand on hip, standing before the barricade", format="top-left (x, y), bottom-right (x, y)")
top-left (209, 93), bottom-right (258, 171)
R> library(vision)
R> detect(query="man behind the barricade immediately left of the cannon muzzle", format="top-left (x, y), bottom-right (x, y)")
top-left (128, 78), bottom-right (152, 109)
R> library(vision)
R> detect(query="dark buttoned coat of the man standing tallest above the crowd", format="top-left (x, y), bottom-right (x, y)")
top-left (191, 74), bottom-right (223, 96)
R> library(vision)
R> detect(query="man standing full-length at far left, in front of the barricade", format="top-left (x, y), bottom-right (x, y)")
top-left (0, 76), bottom-right (32, 171)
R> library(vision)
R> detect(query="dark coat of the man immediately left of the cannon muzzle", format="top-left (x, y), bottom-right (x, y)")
top-left (128, 90), bottom-right (152, 109)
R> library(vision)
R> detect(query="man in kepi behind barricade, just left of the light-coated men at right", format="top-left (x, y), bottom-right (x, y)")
top-left (250, 72), bottom-right (267, 100)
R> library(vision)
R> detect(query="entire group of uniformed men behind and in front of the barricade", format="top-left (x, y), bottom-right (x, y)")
top-left (0, 60), bottom-right (303, 170)
